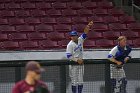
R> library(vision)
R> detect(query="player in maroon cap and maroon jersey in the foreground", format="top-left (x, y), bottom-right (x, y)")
top-left (12, 61), bottom-right (49, 93)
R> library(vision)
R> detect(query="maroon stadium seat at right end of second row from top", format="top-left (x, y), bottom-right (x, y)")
top-left (109, 8), bottom-right (125, 17)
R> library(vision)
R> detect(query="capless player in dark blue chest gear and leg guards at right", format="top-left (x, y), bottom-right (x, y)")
top-left (108, 36), bottom-right (131, 93)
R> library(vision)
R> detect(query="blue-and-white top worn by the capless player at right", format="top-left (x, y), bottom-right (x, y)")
top-left (108, 45), bottom-right (132, 64)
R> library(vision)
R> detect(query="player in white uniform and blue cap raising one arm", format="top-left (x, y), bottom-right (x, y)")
top-left (66, 21), bottom-right (93, 93)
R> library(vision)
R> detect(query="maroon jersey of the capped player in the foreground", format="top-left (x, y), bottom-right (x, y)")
top-left (12, 80), bottom-right (48, 93)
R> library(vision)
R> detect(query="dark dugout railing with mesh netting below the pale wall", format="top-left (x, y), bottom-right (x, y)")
top-left (0, 59), bottom-right (140, 93)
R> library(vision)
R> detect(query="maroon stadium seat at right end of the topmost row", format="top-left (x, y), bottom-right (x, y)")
top-left (97, 0), bottom-right (113, 9)
